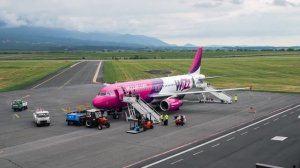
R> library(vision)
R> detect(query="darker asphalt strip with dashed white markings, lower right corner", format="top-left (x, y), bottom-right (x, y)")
top-left (140, 105), bottom-right (300, 168)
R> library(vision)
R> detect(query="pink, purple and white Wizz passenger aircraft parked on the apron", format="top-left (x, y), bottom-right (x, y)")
top-left (93, 48), bottom-right (247, 111)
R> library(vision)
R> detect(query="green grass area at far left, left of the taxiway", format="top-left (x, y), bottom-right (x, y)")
top-left (0, 60), bottom-right (74, 92)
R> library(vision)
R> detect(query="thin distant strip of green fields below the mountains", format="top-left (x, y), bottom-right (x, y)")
top-left (0, 50), bottom-right (300, 60)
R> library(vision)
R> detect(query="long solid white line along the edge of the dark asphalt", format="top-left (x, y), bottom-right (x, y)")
top-left (143, 105), bottom-right (300, 168)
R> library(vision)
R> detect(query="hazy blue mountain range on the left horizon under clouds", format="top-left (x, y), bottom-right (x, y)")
top-left (0, 27), bottom-right (169, 50)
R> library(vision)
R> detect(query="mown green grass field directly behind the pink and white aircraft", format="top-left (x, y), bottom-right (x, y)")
top-left (104, 55), bottom-right (300, 93)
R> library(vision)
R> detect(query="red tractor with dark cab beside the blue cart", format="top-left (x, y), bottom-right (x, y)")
top-left (85, 109), bottom-right (110, 130)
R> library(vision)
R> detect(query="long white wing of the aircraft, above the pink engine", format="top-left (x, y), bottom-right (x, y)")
top-left (151, 87), bottom-right (250, 98)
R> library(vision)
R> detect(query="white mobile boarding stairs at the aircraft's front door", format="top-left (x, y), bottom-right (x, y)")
top-left (123, 97), bottom-right (161, 123)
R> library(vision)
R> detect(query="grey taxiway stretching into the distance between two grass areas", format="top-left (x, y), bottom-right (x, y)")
top-left (32, 61), bottom-right (102, 89)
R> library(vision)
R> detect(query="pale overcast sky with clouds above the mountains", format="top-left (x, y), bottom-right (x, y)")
top-left (0, 0), bottom-right (300, 46)
